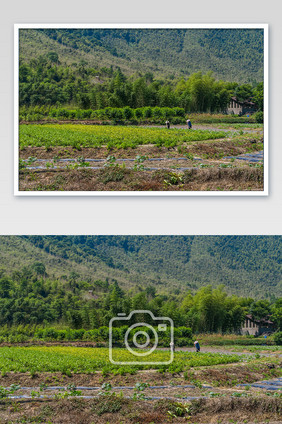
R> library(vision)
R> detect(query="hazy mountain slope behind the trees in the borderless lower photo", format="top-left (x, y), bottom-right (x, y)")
top-left (0, 236), bottom-right (282, 298)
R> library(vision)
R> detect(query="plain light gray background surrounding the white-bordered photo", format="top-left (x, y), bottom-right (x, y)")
top-left (0, 0), bottom-right (282, 234)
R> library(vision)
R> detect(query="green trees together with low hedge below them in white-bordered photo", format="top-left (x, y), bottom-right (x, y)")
top-left (19, 57), bottom-right (263, 114)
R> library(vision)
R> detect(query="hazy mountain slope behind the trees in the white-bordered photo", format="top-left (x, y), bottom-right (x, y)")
top-left (20, 28), bottom-right (263, 83)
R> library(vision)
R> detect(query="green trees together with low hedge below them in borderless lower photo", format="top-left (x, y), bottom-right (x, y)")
top-left (0, 262), bottom-right (278, 338)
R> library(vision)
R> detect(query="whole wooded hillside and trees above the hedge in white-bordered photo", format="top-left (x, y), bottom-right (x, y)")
top-left (19, 29), bottom-right (263, 115)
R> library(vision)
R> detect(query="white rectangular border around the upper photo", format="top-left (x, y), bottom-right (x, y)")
top-left (14, 23), bottom-right (269, 197)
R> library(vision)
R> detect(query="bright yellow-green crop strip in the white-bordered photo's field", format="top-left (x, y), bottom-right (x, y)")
top-left (19, 124), bottom-right (228, 149)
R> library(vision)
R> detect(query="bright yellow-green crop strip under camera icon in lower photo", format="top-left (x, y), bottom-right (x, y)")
top-left (0, 346), bottom-right (240, 375)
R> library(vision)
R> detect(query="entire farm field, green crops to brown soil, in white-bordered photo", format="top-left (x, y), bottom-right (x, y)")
top-left (19, 123), bottom-right (263, 191)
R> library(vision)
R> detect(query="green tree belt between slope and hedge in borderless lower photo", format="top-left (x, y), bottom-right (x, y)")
top-left (0, 262), bottom-right (282, 333)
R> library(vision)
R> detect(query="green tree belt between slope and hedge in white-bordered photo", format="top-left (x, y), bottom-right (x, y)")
top-left (19, 52), bottom-right (263, 112)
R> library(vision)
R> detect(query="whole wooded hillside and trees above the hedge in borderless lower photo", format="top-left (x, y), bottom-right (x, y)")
top-left (0, 236), bottom-right (282, 333)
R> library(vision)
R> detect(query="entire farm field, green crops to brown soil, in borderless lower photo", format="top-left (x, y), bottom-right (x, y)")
top-left (0, 346), bottom-right (282, 424)
